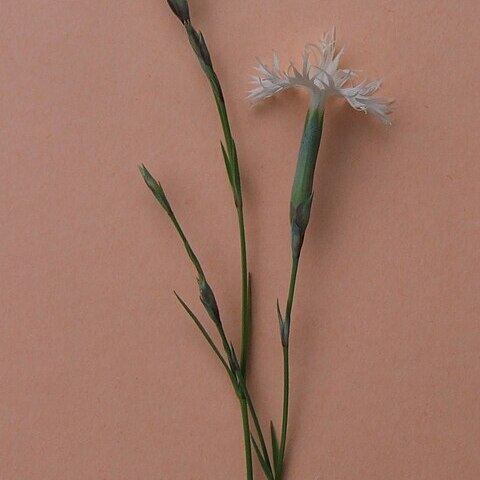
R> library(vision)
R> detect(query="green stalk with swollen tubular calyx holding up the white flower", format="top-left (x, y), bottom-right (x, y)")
top-left (275, 107), bottom-right (324, 480)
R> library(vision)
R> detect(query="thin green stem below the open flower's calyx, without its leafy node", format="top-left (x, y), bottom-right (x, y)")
top-left (277, 255), bottom-right (300, 480)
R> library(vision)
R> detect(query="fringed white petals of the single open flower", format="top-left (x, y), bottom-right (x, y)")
top-left (248, 29), bottom-right (393, 125)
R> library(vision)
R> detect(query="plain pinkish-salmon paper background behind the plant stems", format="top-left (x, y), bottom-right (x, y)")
top-left (0, 0), bottom-right (480, 480)
